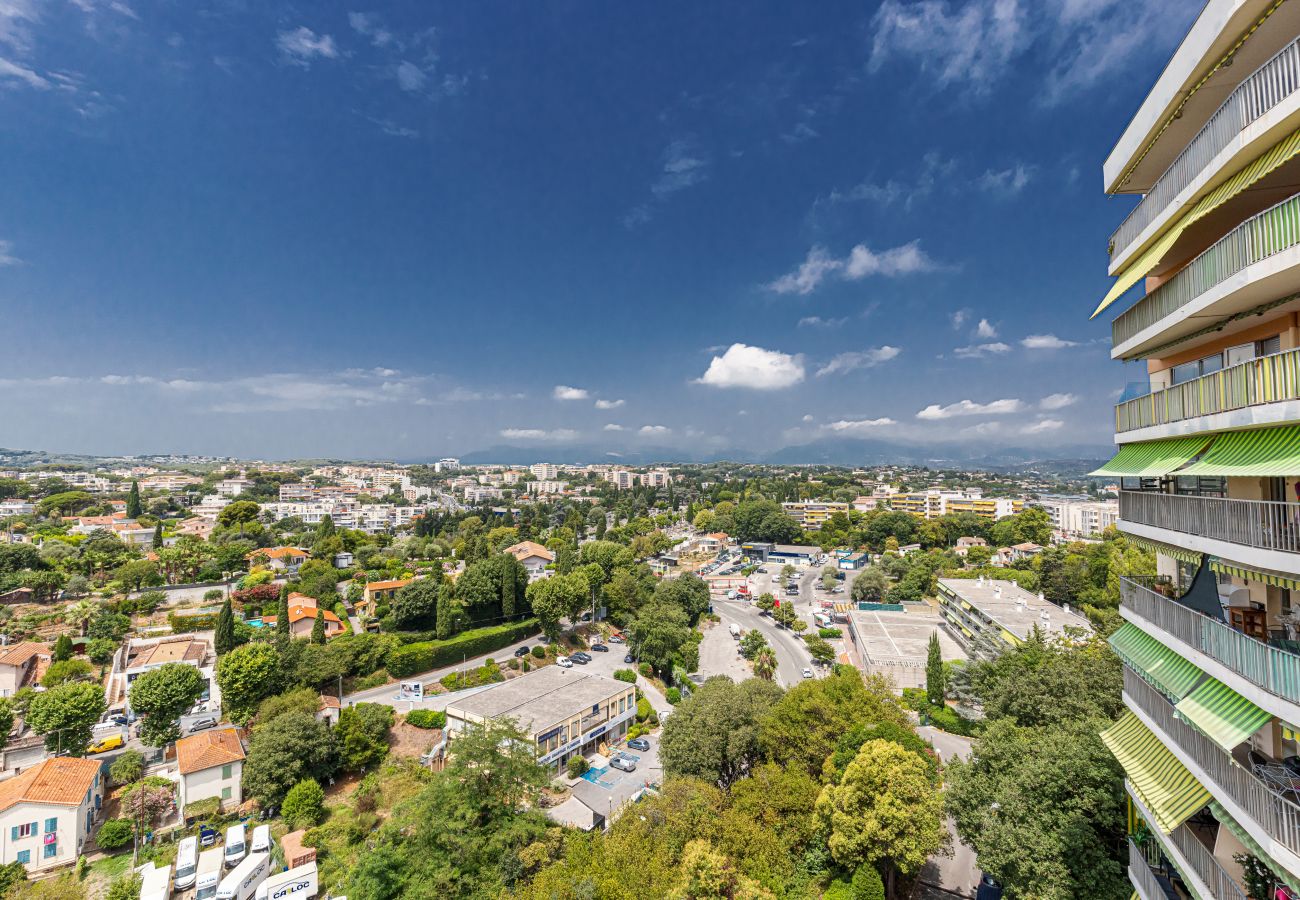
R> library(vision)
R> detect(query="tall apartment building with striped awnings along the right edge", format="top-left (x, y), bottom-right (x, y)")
top-left (1093, 0), bottom-right (1300, 900)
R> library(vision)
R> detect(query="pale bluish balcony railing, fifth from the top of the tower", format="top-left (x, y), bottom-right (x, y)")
top-left (1119, 579), bottom-right (1300, 704)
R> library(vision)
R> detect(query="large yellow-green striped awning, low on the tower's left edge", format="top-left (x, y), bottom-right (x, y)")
top-left (1101, 711), bottom-right (1210, 835)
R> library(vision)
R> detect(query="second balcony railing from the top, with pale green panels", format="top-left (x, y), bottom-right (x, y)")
top-left (1110, 188), bottom-right (1300, 346)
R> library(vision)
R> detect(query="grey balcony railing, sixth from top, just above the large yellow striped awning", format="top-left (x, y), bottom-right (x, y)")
top-left (1125, 667), bottom-right (1300, 852)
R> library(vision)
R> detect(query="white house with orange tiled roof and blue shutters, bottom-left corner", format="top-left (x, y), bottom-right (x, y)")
top-left (0, 756), bottom-right (105, 873)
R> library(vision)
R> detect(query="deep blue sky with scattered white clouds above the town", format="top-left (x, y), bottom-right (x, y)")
top-left (0, 0), bottom-right (1195, 458)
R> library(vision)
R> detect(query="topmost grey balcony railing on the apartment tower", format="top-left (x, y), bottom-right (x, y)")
top-left (1110, 39), bottom-right (1300, 264)
